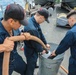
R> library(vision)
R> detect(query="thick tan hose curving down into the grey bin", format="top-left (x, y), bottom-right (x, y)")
top-left (2, 35), bottom-right (48, 75)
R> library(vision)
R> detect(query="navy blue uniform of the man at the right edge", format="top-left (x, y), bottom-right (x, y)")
top-left (55, 24), bottom-right (76, 75)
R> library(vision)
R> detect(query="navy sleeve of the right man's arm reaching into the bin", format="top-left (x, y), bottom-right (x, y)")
top-left (55, 31), bottom-right (74, 55)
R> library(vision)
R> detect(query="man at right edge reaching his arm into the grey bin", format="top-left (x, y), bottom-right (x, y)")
top-left (51, 10), bottom-right (76, 75)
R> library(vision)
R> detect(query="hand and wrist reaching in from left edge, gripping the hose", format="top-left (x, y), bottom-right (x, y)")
top-left (0, 38), bottom-right (14, 53)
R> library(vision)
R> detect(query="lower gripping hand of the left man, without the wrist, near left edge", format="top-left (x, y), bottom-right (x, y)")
top-left (3, 38), bottom-right (14, 51)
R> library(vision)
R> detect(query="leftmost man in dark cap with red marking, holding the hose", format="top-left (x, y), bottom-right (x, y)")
top-left (0, 4), bottom-right (29, 75)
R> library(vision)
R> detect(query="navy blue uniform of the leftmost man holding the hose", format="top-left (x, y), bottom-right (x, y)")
top-left (0, 22), bottom-right (26, 75)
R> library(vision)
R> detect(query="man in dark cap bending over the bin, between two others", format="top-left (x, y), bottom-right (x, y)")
top-left (24, 8), bottom-right (50, 75)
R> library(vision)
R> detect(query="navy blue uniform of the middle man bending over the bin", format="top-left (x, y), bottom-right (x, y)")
top-left (24, 17), bottom-right (47, 75)
